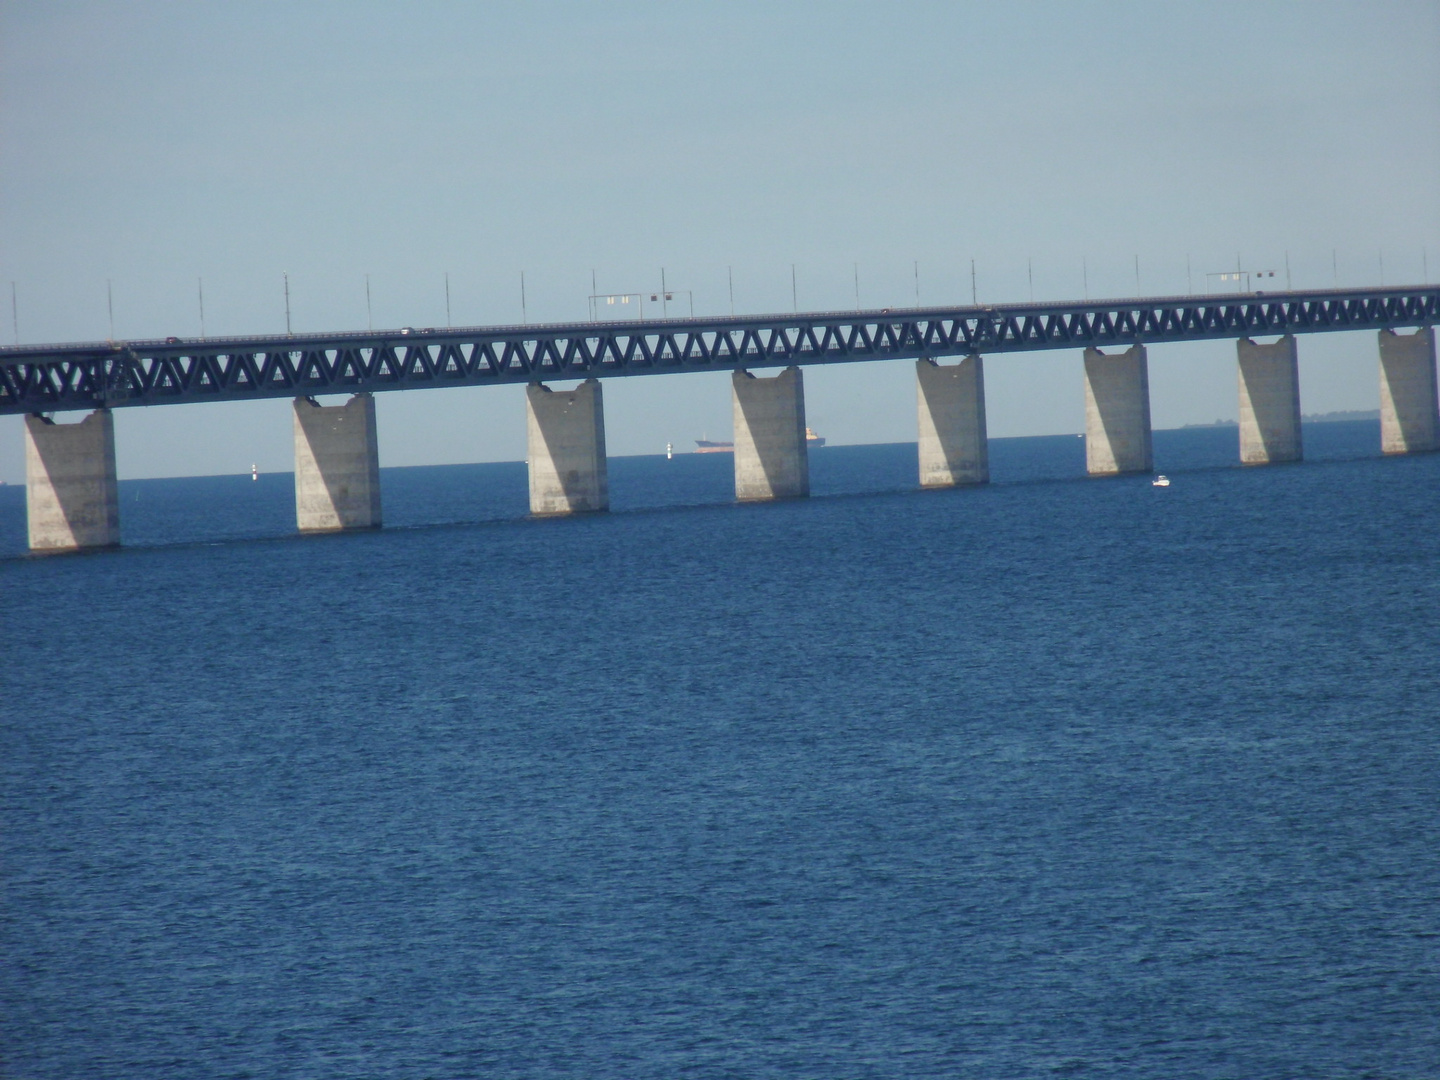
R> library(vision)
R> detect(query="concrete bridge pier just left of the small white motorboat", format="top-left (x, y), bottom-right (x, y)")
top-left (1084, 346), bottom-right (1155, 477)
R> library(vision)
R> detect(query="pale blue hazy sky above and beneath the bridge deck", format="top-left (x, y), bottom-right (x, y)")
top-left (0, 0), bottom-right (1440, 482)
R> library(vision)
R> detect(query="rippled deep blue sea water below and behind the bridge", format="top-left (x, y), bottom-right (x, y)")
top-left (0, 422), bottom-right (1440, 1080)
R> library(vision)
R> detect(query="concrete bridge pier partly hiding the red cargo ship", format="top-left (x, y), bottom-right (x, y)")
top-left (730, 367), bottom-right (809, 503)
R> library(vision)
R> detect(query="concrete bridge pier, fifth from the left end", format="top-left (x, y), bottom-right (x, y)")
top-left (914, 356), bottom-right (989, 488)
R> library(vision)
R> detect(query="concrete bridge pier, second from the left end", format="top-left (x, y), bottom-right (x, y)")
top-left (295, 393), bottom-right (380, 533)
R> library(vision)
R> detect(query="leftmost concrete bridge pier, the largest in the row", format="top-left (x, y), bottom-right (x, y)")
top-left (24, 409), bottom-right (120, 552)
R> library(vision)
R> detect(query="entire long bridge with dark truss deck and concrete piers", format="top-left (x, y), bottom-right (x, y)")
top-left (0, 285), bottom-right (1440, 550)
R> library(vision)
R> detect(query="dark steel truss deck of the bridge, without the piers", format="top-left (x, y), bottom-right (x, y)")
top-left (0, 285), bottom-right (1440, 415)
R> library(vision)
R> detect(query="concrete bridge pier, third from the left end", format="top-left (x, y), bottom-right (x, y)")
top-left (526, 379), bottom-right (611, 514)
